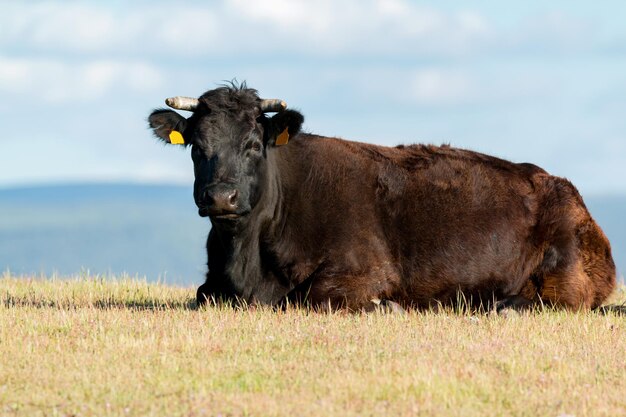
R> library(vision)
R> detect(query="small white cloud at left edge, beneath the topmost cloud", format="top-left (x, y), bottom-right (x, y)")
top-left (0, 56), bottom-right (163, 103)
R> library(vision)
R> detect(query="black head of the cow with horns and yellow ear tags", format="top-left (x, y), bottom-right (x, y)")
top-left (148, 85), bottom-right (304, 221)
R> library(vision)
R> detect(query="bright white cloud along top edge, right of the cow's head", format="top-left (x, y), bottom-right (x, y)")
top-left (228, 0), bottom-right (490, 56)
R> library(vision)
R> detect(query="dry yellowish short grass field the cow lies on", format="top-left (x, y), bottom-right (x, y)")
top-left (0, 274), bottom-right (626, 417)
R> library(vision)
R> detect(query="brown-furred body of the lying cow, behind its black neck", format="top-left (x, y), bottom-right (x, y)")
top-left (279, 137), bottom-right (615, 309)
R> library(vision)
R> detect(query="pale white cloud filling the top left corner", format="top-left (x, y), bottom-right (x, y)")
top-left (0, 2), bottom-right (218, 55)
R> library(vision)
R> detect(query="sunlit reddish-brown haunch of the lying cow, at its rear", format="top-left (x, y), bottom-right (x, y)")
top-left (532, 177), bottom-right (616, 310)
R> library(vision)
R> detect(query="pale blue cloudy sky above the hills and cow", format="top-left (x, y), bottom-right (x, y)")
top-left (0, 0), bottom-right (626, 195)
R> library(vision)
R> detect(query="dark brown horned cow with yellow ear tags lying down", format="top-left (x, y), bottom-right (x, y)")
top-left (148, 83), bottom-right (616, 311)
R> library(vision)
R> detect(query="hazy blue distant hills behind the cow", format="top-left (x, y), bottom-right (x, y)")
top-left (0, 184), bottom-right (626, 285)
